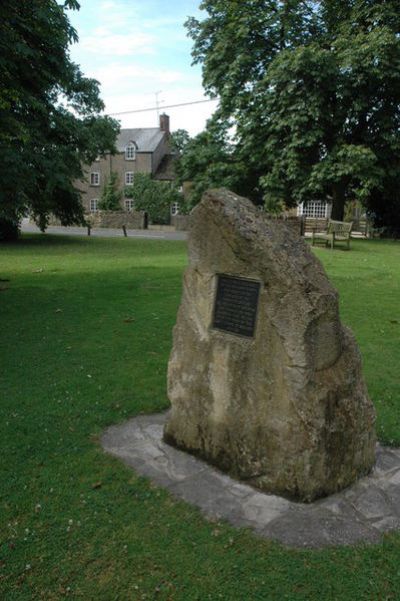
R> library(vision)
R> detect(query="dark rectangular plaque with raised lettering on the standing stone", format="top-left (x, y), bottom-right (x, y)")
top-left (212, 275), bottom-right (261, 338)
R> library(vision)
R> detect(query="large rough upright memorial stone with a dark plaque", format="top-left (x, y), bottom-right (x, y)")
top-left (164, 190), bottom-right (376, 501)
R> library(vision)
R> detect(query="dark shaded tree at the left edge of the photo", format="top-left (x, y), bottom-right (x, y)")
top-left (0, 0), bottom-right (119, 238)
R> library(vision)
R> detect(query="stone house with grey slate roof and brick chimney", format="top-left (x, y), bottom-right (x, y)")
top-left (79, 114), bottom-right (174, 214)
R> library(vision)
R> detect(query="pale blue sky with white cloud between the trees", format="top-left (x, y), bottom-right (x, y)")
top-left (69, 0), bottom-right (216, 135)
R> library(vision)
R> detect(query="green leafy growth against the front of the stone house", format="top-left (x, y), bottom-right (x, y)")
top-left (125, 173), bottom-right (183, 224)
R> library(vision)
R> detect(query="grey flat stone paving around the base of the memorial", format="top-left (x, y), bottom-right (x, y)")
top-left (101, 414), bottom-right (400, 548)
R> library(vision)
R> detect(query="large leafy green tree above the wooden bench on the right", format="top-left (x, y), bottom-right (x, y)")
top-left (187, 0), bottom-right (400, 226)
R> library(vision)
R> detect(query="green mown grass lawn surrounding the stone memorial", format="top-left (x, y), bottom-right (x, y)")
top-left (0, 235), bottom-right (400, 601)
